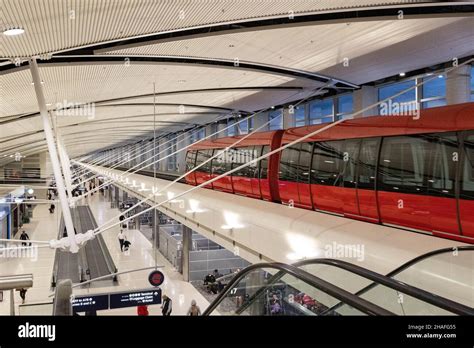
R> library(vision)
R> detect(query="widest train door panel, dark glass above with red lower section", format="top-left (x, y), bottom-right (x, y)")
top-left (377, 135), bottom-right (431, 231)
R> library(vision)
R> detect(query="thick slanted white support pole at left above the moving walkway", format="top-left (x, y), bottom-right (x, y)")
top-left (29, 58), bottom-right (79, 253)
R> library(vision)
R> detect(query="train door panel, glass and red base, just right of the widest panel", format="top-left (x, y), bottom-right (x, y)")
top-left (423, 133), bottom-right (459, 237)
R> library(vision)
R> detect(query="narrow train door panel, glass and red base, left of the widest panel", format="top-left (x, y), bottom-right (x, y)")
top-left (357, 138), bottom-right (380, 222)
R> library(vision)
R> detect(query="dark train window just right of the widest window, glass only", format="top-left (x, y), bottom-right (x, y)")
top-left (426, 134), bottom-right (458, 197)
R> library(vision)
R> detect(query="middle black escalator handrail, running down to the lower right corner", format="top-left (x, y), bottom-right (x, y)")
top-left (293, 258), bottom-right (474, 315)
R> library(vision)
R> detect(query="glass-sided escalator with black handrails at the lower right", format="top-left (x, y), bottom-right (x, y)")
top-left (204, 246), bottom-right (474, 316)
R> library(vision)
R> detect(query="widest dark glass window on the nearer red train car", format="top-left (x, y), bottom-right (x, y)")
top-left (379, 136), bottom-right (430, 194)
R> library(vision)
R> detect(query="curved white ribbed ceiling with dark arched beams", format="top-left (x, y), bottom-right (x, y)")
top-left (0, 0), bottom-right (474, 165)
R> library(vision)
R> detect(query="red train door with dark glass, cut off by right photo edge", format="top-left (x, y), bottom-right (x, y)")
top-left (459, 131), bottom-right (474, 238)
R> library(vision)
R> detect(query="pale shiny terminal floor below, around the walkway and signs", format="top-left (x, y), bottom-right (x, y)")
top-left (0, 194), bottom-right (209, 315)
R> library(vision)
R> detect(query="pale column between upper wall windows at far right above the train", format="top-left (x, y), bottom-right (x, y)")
top-left (446, 64), bottom-right (471, 105)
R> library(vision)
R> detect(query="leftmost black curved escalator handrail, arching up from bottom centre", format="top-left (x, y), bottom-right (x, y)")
top-left (203, 262), bottom-right (394, 315)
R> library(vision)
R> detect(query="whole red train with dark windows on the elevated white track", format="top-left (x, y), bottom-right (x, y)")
top-left (187, 103), bottom-right (474, 243)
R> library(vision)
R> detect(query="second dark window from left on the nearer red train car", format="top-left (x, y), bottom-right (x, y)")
top-left (311, 140), bottom-right (344, 186)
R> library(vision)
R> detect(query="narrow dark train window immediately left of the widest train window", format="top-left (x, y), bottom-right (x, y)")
top-left (357, 138), bottom-right (379, 190)
